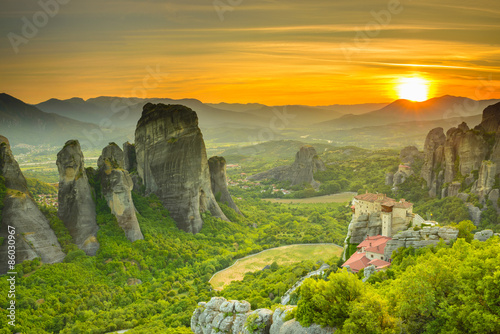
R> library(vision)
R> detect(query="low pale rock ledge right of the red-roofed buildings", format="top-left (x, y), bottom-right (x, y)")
top-left (384, 226), bottom-right (458, 260)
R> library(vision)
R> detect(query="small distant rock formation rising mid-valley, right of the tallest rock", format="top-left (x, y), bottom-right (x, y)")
top-left (248, 145), bottom-right (326, 189)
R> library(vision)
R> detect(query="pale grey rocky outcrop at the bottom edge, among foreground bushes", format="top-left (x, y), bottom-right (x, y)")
top-left (191, 297), bottom-right (335, 334)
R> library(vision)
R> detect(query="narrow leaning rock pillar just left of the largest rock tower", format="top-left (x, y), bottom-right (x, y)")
top-left (97, 143), bottom-right (144, 241)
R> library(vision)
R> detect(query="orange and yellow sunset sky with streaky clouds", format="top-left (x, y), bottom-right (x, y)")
top-left (0, 0), bottom-right (500, 105)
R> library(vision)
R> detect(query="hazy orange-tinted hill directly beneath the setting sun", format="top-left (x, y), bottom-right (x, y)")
top-left (318, 95), bottom-right (498, 130)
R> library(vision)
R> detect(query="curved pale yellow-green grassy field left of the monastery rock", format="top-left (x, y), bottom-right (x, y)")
top-left (210, 244), bottom-right (342, 290)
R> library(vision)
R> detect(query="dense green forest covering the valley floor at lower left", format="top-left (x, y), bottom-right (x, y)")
top-left (0, 171), bottom-right (349, 334)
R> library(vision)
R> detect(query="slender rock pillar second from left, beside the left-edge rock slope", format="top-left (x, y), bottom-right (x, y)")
top-left (57, 140), bottom-right (99, 255)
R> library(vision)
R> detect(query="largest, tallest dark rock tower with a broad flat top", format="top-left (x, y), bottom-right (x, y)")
top-left (135, 103), bottom-right (227, 233)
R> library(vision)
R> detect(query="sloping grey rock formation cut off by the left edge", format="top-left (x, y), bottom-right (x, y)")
top-left (0, 136), bottom-right (65, 274)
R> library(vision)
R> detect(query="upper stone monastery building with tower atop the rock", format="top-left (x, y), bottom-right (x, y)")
top-left (351, 192), bottom-right (413, 237)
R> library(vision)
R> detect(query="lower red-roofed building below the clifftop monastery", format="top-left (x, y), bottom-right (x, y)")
top-left (342, 235), bottom-right (392, 273)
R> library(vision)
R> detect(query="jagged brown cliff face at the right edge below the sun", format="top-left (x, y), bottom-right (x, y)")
top-left (421, 103), bottom-right (500, 202)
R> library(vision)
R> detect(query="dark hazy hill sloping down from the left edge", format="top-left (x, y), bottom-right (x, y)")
top-left (0, 93), bottom-right (112, 145)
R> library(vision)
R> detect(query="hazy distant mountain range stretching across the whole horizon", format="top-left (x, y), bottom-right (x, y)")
top-left (0, 94), bottom-right (500, 148)
